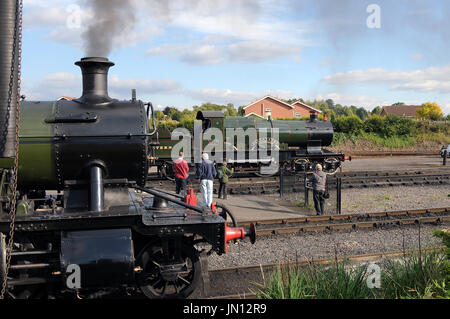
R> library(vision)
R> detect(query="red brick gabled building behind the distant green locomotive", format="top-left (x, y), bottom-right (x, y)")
top-left (244, 95), bottom-right (322, 119)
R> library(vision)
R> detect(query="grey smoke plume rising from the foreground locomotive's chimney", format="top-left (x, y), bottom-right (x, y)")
top-left (83, 0), bottom-right (136, 57)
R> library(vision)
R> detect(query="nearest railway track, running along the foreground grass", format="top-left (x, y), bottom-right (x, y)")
top-left (207, 246), bottom-right (445, 299)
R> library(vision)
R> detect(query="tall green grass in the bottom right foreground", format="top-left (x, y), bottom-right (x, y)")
top-left (252, 230), bottom-right (450, 299)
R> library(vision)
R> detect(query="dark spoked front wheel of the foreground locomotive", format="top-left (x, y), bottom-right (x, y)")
top-left (137, 240), bottom-right (201, 299)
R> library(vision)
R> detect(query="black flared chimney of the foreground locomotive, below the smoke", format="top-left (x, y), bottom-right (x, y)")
top-left (74, 57), bottom-right (114, 104)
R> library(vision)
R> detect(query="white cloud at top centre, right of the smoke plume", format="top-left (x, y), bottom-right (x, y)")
top-left (138, 0), bottom-right (311, 44)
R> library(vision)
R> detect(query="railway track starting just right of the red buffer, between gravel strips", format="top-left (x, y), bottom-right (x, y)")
top-left (239, 207), bottom-right (450, 236)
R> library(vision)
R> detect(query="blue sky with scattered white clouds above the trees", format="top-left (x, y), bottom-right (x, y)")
top-left (22, 0), bottom-right (450, 114)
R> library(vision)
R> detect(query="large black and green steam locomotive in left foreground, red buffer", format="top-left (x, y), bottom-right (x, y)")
top-left (0, 0), bottom-right (255, 298)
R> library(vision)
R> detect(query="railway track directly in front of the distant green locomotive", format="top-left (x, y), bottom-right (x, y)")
top-left (152, 170), bottom-right (450, 195)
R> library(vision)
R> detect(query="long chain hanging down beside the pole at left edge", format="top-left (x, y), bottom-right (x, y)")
top-left (0, 0), bottom-right (23, 299)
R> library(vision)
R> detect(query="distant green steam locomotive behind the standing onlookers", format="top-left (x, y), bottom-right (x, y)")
top-left (150, 111), bottom-right (350, 178)
